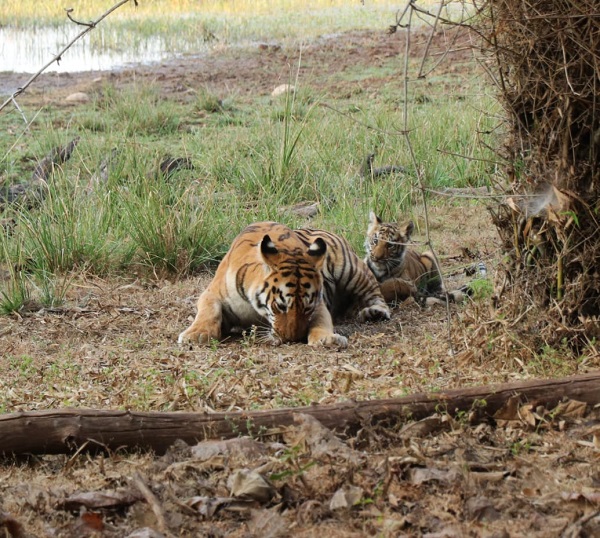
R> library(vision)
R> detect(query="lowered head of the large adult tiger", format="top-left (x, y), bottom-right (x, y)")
top-left (255, 235), bottom-right (327, 343)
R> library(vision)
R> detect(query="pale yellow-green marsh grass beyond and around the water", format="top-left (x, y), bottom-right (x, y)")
top-left (0, 0), bottom-right (433, 47)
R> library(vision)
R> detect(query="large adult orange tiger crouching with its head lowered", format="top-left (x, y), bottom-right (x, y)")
top-left (179, 222), bottom-right (390, 348)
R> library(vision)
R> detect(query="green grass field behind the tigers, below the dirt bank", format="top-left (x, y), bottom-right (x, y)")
top-left (0, 2), bottom-right (498, 313)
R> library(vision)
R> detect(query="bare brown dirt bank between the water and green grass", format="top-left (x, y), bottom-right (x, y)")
top-left (0, 27), bottom-right (472, 105)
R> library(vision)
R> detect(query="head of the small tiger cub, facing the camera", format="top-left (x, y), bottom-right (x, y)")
top-left (365, 211), bottom-right (415, 281)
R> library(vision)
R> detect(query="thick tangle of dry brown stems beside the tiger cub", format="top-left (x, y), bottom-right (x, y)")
top-left (473, 0), bottom-right (600, 349)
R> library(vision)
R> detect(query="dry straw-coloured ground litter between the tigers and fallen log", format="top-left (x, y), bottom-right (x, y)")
top-left (0, 204), bottom-right (510, 411)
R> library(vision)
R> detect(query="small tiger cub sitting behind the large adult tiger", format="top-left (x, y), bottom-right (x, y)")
top-left (365, 211), bottom-right (443, 303)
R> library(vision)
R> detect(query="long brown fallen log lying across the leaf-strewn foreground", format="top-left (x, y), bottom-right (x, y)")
top-left (0, 372), bottom-right (600, 455)
